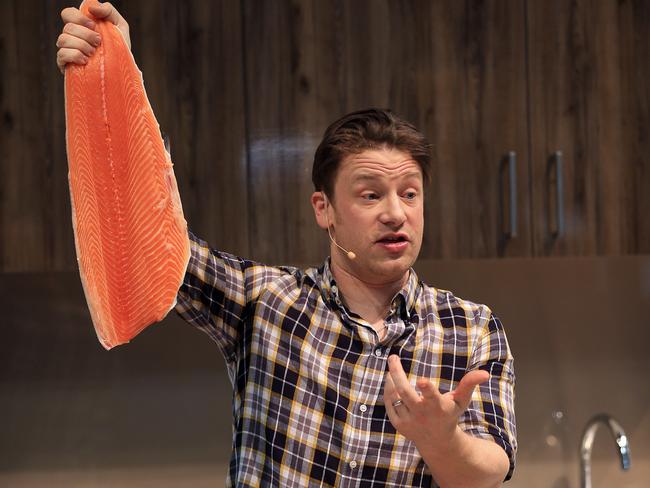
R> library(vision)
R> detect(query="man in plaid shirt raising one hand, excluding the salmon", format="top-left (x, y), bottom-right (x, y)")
top-left (57, 3), bottom-right (516, 487)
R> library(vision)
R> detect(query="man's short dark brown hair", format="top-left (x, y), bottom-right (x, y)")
top-left (311, 108), bottom-right (431, 200)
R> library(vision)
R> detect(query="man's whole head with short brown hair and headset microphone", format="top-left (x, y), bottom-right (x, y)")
top-left (312, 109), bottom-right (430, 285)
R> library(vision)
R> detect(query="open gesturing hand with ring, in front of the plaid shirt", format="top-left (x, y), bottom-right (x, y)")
top-left (384, 354), bottom-right (490, 446)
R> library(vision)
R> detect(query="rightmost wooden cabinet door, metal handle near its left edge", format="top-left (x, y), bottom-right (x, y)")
top-left (528, 0), bottom-right (650, 256)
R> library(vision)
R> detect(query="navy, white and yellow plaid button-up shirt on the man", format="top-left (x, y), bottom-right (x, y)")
top-left (176, 233), bottom-right (516, 487)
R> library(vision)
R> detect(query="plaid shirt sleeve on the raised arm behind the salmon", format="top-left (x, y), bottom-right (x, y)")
top-left (175, 232), bottom-right (285, 362)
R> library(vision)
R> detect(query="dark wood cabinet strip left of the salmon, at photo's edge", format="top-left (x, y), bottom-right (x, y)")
top-left (0, 1), bottom-right (76, 271)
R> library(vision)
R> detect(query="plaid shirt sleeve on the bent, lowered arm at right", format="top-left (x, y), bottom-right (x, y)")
top-left (459, 310), bottom-right (517, 481)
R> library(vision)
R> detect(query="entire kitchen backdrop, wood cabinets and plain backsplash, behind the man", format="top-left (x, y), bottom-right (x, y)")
top-left (0, 0), bottom-right (650, 488)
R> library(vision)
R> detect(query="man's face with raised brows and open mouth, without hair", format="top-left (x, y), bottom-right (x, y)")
top-left (316, 147), bottom-right (424, 284)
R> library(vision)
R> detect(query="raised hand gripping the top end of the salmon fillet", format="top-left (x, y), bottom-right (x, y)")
top-left (56, 0), bottom-right (131, 73)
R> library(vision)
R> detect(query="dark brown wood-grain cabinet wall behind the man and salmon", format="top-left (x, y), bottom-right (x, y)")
top-left (0, 0), bottom-right (650, 271)
